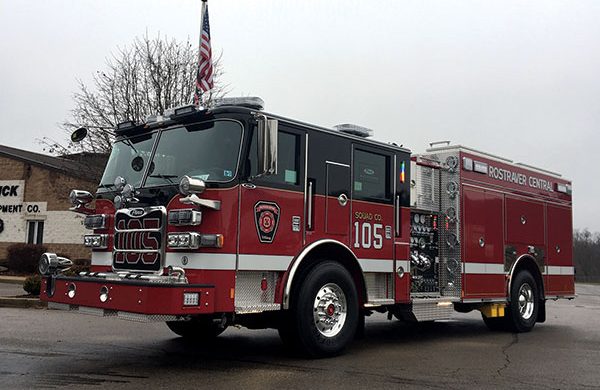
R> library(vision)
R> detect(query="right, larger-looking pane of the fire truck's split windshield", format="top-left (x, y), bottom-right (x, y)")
top-left (145, 120), bottom-right (242, 187)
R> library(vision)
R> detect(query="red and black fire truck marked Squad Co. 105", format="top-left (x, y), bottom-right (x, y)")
top-left (39, 98), bottom-right (574, 357)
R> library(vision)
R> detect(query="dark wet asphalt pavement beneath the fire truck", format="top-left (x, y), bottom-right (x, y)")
top-left (0, 285), bottom-right (600, 390)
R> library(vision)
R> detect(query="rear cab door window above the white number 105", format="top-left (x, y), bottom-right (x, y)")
top-left (352, 149), bottom-right (391, 201)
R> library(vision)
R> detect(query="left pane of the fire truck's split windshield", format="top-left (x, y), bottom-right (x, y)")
top-left (100, 133), bottom-right (156, 189)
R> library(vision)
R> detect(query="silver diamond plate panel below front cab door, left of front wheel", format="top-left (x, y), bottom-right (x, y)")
top-left (235, 271), bottom-right (281, 313)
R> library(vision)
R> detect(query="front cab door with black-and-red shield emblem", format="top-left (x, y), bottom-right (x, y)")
top-left (237, 123), bottom-right (306, 271)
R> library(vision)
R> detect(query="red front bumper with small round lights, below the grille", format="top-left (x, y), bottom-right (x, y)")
top-left (40, 275), bottom-right (215, 321)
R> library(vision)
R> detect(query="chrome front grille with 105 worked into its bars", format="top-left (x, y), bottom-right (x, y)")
top-left (113, 206), bottom-right (167, 273)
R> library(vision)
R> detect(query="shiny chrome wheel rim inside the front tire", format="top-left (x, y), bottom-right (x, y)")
top-left (313, 283), bottom-right (348, 337)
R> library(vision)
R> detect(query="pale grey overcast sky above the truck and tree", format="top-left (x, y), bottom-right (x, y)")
top-left (0, 0), bottom-right (600, 231)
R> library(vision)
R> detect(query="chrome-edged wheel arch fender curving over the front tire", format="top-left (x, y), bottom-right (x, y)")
top-left (282, 239), bottom-right (367, 310)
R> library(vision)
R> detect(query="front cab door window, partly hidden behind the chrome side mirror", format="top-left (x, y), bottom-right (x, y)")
top-left (249, 131), bottom-right (301, 186)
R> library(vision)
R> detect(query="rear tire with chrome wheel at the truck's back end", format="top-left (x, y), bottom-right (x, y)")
top-left (506, 270), bottom-right (540, 333)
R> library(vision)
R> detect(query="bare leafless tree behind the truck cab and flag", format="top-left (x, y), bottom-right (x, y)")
top-left (39, 35), bottom-right (224, 155)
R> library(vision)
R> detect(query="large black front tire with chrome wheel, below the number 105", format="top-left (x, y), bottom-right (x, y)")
top-left (280, 261), bottom-right (359, 357)
